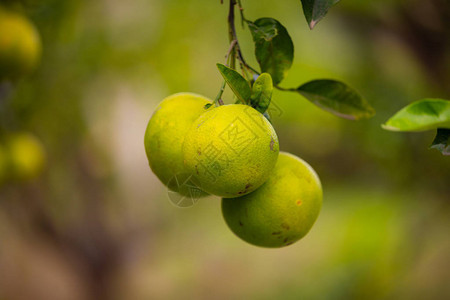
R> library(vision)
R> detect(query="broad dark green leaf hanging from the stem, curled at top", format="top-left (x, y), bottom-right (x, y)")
top-left (248, 18), bottom-right (294, 85)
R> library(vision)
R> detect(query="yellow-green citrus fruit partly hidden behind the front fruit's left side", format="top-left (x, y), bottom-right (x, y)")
top-left (144, 93), bottom-right (211, 196)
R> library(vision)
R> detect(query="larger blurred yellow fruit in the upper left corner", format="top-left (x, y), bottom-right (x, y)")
top-left (0, 8), bottom-right (42, 80)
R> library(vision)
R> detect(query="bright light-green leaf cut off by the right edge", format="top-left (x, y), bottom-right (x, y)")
top-left (381, 99), bottom-right (450, 131)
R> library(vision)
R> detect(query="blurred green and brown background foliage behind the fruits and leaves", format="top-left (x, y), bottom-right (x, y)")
top-left (0, 0), bottom-right (450, 300)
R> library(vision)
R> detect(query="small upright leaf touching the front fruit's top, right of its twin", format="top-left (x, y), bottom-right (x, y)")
top-left (250, 73), bottom-right (273, 114)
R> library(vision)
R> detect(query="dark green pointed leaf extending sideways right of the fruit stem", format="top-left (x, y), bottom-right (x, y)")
top-left (297, 79), bottom-right (375, 120)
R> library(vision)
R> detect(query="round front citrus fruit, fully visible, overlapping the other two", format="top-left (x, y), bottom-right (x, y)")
top-left (183, 104), bottom-right (279, 198)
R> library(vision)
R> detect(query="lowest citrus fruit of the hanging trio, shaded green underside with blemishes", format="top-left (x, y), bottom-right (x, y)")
top-left (222, 152), bottom-right (322, 248)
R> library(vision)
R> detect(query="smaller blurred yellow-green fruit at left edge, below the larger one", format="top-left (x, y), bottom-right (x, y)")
top-left (6, 133), bottom-right (46, 180)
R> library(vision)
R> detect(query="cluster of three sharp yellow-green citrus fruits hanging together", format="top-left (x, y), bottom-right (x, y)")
top-left (144, 93), bottom-right (322, 247)
